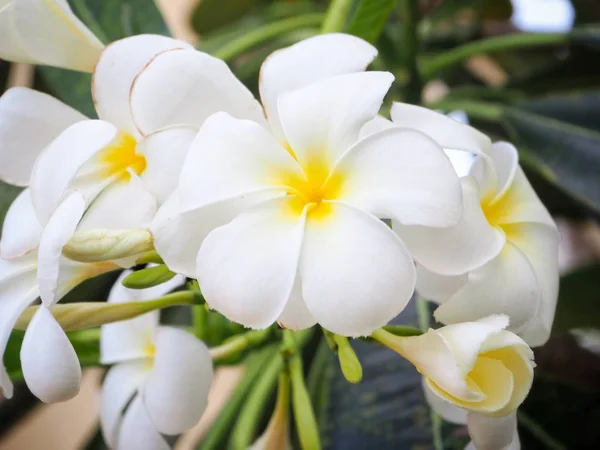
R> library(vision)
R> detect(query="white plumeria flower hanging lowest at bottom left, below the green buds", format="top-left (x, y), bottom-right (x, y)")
top-left (100, 271), bottom-right (213, 450)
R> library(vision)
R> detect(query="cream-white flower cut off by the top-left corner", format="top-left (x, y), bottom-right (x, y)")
top-left (0, 0), bottom-right (104, 72)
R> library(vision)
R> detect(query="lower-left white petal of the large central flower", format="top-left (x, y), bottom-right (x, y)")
top-left (196, 197), bottom-right (305, 328)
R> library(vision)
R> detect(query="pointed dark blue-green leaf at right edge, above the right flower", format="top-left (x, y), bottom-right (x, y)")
top-left (503, 108), bottom-right (600, 212)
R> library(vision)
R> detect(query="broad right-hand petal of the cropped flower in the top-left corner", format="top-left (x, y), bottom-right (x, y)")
top-left (14, 0), bottom-right (104, 72)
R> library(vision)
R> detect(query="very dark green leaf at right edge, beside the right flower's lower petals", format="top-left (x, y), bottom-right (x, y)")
top-left (552, 264), bottom-right (600, 332)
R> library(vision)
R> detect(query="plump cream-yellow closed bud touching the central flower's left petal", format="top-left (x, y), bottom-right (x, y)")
top-left (63, 228), bottom-right (154, 262)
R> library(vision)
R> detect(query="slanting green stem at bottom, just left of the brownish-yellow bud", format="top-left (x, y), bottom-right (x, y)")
top-left (229, 355), bottom-right (283, 450)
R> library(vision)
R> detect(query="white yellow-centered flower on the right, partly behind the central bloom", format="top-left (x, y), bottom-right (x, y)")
top-left (371, 103), bottom-right (559, 346)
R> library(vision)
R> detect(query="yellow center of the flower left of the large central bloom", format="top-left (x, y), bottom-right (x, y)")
top-left (98, 132), bottom-right (146, 181)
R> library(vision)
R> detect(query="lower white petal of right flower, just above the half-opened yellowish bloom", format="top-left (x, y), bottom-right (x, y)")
top-left (435, 242), bottom-right (541, 333)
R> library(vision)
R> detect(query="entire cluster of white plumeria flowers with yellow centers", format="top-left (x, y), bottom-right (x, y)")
top-left (0, 0), bottom-right (558, 449)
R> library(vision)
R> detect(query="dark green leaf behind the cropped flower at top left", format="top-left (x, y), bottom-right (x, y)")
top-left (38, 0), bottom-right (169, 118)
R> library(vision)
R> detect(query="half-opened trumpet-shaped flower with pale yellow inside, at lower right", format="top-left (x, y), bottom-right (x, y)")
top-left (373, 315), bottom-right (534, 417)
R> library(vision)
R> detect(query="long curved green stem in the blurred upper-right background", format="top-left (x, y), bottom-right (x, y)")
top-left (422, 33), bottom-right (569, 79)
